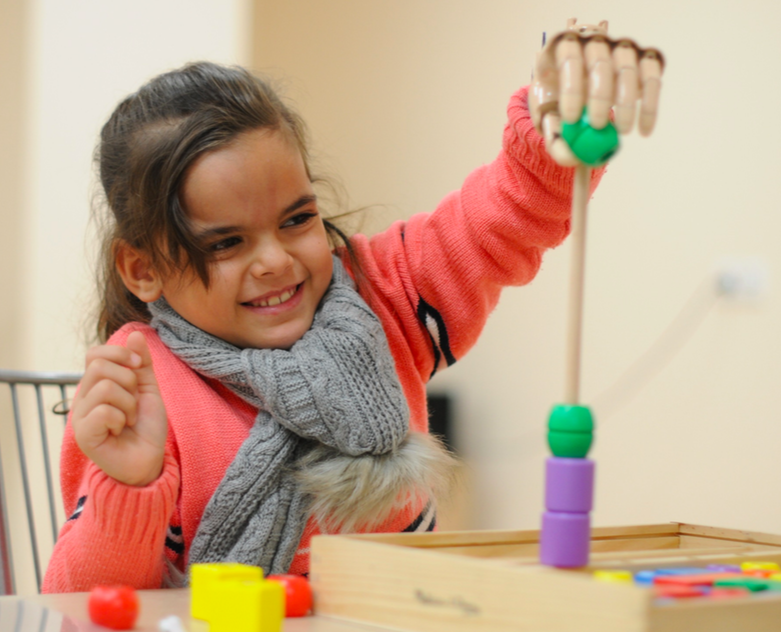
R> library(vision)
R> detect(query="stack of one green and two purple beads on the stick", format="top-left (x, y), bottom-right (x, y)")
top-left (540, 405), bottom-right (595, 568)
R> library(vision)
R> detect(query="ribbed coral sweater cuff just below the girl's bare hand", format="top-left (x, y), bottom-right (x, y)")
top-left (84, 450), bottom-right (180, 546)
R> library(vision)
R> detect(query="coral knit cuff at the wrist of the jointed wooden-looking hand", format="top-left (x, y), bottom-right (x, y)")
top-left (503, 86), bottom-right (605, 199)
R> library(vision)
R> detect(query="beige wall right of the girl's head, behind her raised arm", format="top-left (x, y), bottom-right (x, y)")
top-left (254, 0), bottom-right (781, 532)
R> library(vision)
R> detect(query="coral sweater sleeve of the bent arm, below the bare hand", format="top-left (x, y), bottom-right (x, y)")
top-left (42, 332), bottom-right (180, 593)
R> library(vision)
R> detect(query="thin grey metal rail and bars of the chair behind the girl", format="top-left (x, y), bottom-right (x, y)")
top-left (0, 369), bottom-right (82, 594)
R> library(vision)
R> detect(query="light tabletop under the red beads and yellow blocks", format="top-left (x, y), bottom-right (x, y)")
top-left (0, 588), bottom-right (387, 632)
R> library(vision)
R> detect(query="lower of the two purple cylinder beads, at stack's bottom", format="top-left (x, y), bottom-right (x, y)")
top-left (540, 511), bottom-right (591, 568)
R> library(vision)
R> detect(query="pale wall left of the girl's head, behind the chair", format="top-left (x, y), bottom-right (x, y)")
top-left (0, 0), bottom-right (252, 593)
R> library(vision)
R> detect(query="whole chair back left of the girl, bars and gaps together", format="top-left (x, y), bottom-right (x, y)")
top-left (0, 369), bottom-right (81, 595)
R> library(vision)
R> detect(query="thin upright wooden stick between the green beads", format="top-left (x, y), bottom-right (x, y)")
top-left (564, 164), bottom-right (591, 405)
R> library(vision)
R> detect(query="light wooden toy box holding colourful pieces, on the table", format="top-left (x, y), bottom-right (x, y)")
top-left (310, 523), bottom-right (781, 632)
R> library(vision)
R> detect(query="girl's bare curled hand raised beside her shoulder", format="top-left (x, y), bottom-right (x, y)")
top-left (71, 331), bottom-right (168, 486)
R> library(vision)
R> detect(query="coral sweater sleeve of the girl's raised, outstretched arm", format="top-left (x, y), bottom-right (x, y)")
top-left (353, 83), bottom-right (604, 380)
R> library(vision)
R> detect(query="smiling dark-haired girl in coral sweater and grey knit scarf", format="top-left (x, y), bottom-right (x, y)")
top-left (43, 63), bottom-right (601, 592)
